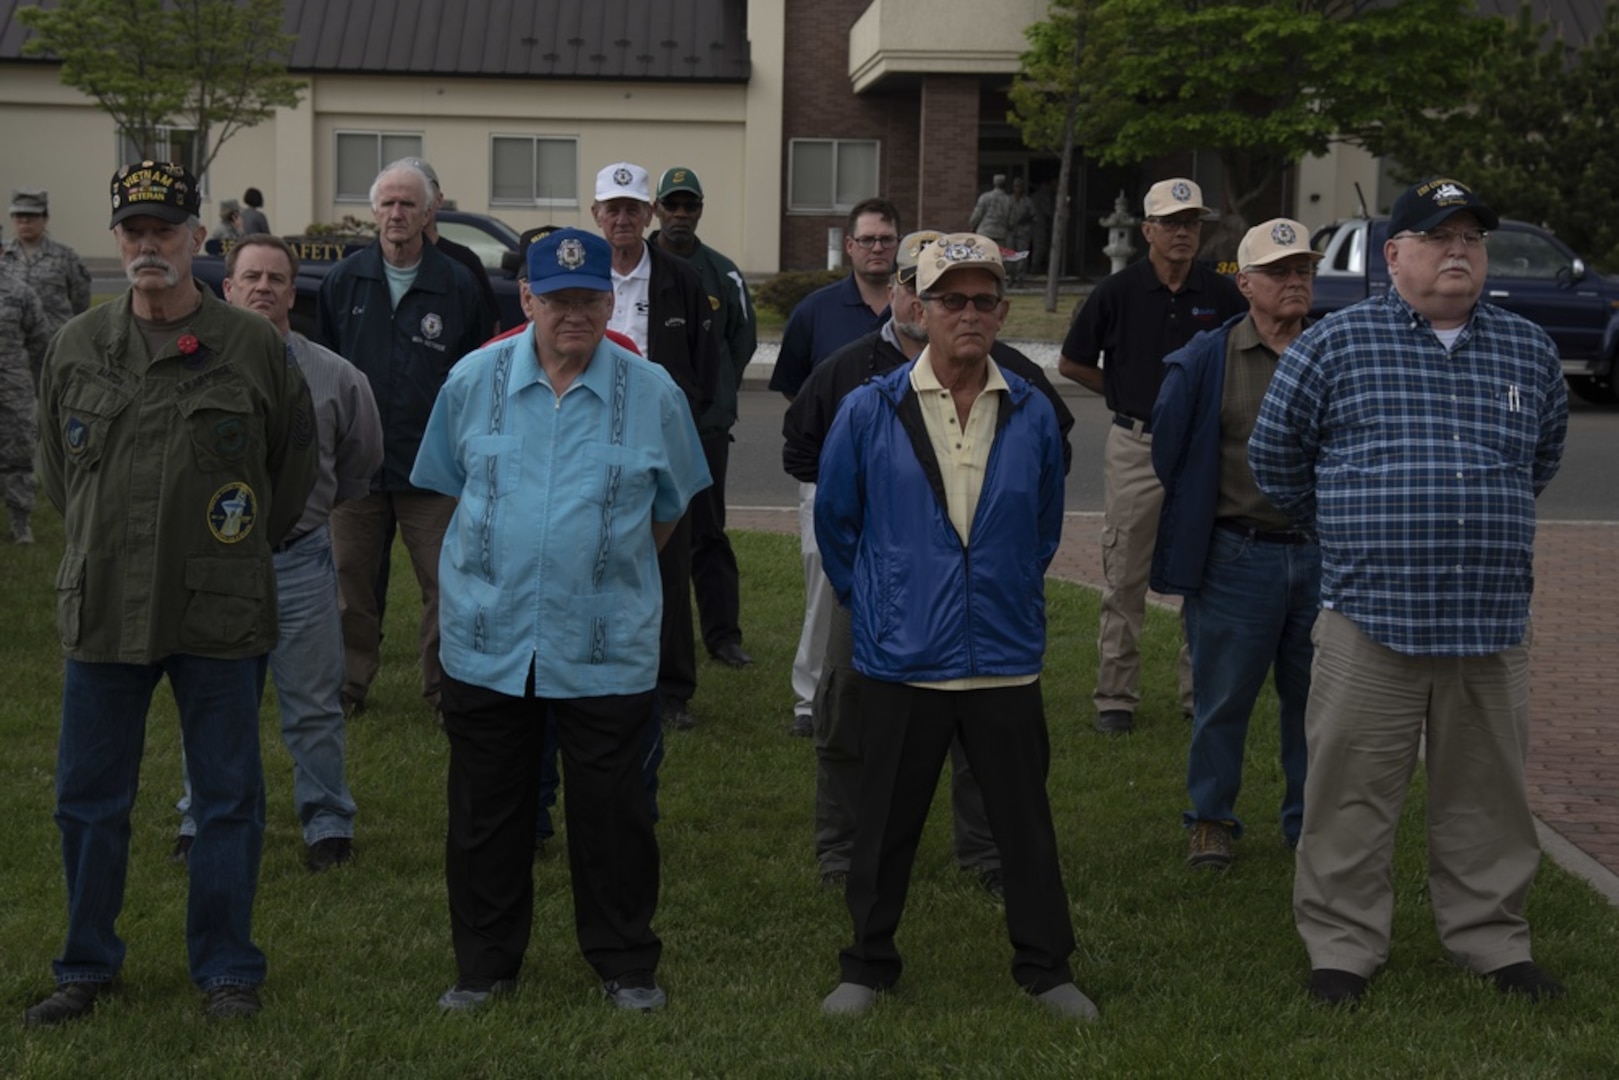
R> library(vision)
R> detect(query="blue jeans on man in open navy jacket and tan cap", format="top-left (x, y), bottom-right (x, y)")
top-left (1182, 528), bottom-right (1321, 844)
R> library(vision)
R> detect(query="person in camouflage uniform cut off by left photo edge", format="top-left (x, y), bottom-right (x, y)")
top-left (0, 264), bottom-right (57, 544)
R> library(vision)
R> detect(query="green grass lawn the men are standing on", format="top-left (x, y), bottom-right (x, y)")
top-left (0, 510), bottom-right (1619, 1078)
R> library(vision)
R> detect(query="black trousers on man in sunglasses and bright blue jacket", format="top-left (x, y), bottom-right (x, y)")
top-left (840, 675), bottom-right (1073, 994)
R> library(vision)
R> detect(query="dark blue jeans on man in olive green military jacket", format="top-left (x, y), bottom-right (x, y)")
top-left (52, 654), bottom-right (266, 991)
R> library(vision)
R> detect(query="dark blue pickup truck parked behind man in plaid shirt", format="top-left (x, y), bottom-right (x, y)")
top-left (1311, 217), bottom-right (1619, 405)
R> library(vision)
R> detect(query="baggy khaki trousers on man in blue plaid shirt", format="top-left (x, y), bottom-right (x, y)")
top-left (1294, 610), bottom-right (1540, 978)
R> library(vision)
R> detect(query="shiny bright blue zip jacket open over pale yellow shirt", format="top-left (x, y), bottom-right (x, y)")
top-left (814, 364), bottom-right (1062, 682)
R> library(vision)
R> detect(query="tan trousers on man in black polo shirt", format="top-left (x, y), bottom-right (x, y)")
top-left (1093, 424), bottom-right (1192, 716)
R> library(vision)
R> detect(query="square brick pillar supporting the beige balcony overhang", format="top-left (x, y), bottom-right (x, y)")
top-left (916, 74), bottom-right (979, 232)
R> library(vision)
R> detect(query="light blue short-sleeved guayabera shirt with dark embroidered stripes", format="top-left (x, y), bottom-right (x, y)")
top-left (410, 330), bottom-right (711, 698)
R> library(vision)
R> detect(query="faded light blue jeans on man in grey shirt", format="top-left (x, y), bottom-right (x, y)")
top-left (176, 525), bottom-right (355, 844)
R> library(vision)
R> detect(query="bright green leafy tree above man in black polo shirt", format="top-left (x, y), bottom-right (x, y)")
top-left (1013, 0), bottom-right (1488, 255)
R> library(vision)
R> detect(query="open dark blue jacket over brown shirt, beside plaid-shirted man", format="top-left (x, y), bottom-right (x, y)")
top-left (1151, 314), bottom-right (1248, 596)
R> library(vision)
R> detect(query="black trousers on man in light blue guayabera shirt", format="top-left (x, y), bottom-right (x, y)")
top-left (440, 674), bottom-right (662, 984)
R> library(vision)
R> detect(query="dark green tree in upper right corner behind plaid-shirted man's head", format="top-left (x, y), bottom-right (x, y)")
top-left (1379, 5), bottom-right (1619, 272)
